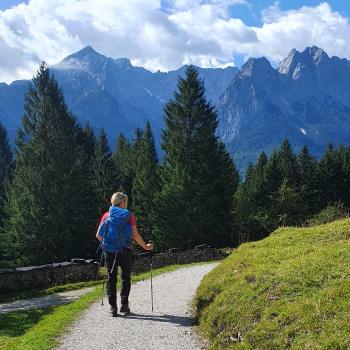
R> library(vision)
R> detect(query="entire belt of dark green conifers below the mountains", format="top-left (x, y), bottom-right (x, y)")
top-left (0, 64), bottom-right (350, 266)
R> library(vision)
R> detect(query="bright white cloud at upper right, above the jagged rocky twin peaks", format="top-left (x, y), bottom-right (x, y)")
top-left (250, 2), bottom-right (350, 61)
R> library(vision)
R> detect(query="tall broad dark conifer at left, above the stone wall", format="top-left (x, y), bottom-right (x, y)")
top-left (5, 64), bottom-right (94, 264)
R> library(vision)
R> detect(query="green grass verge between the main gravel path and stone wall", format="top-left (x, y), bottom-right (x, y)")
top-left (0, 263), bottom-right (213, 350)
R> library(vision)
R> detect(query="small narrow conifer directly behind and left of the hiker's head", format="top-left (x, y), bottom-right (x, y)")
top-left (91, 129), bottom-right (117, 217)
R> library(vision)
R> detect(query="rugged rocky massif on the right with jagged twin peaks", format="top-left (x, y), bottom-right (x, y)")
top-left (218, 47), bottom-right (350, 170)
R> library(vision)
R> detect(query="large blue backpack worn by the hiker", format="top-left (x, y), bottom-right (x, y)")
top-left (100, 206), bottom-right (131, 253)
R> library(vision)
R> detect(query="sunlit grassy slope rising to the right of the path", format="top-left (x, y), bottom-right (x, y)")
top-left (195, 219), bottom-right (350, 350)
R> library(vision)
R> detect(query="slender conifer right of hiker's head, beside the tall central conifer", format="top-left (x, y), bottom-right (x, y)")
top-left (132, 122), bottom-right (159, 240)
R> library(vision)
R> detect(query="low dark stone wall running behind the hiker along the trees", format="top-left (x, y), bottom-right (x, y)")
top-left (0, 245), bottom-right (227, 293)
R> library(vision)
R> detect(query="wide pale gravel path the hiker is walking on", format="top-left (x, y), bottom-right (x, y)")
top-left (57, 263), bottom-right (217, 350)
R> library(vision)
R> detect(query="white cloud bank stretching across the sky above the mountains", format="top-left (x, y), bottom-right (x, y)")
top-left (0, 0), bottom-right (350, 82)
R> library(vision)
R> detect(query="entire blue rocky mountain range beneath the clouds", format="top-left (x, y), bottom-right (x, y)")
top-left (0, 46), bottom-right (350, 171)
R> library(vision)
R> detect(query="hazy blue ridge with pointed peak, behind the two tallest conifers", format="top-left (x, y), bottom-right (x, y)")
top-left (0, 46), bottom-right (238, 149)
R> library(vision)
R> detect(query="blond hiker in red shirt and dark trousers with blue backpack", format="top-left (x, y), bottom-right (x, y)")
top-left (96, 192), bottom-right (153, 316)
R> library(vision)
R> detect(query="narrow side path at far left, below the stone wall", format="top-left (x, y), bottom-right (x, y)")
top-left (0, 287), bottom-right (94, 314)
